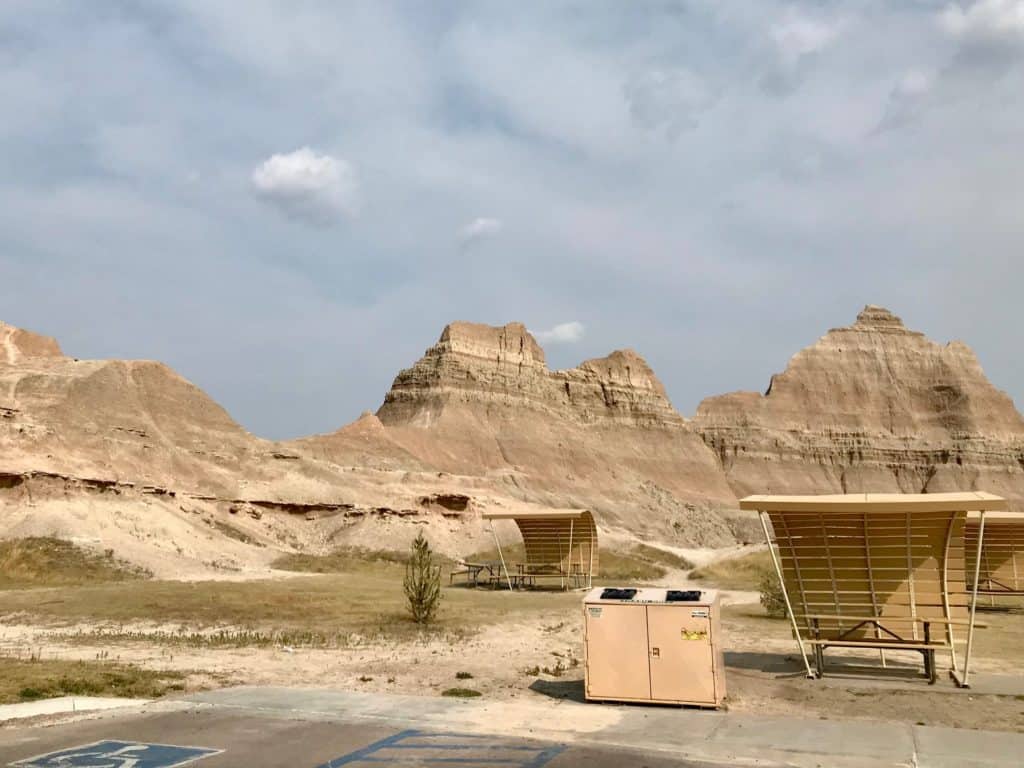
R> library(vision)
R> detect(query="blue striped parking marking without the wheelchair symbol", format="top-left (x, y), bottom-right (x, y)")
top-left (317, 729), bottom-right (565, 768)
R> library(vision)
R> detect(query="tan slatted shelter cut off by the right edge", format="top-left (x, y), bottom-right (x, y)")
top-left (965, 512), bottom-right (1024, 596)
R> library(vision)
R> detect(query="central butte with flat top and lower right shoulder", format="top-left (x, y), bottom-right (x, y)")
top-left (356, 323), bottom-right (736, 544)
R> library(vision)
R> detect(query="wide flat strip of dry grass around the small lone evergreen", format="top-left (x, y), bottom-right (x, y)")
top-left (0, 562), bottom-right (580, 645)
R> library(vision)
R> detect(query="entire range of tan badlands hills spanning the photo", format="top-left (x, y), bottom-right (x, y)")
top-left (0, 307), bottom-right (1024, 577)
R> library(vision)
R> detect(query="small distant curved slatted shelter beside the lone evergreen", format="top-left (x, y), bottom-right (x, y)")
top-left (482, 509), bottom-right (599, 589)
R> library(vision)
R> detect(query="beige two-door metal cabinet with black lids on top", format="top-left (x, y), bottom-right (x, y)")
top-left (583, 587), bottom-right (725, 707)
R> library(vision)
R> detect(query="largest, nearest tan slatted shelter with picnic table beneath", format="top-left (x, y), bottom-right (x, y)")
top-left (739, 492), bottom-right (1007, 686)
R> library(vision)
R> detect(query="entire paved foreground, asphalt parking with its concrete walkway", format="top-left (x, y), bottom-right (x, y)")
top-left (0, 687), bottom-right (1024, 768)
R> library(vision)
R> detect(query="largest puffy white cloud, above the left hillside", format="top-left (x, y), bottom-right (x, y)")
top-left (252, 146), bottom-right (358, 224)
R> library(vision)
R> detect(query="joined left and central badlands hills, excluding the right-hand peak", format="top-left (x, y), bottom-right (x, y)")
top-left (0, 315), bottom-right (749, 575)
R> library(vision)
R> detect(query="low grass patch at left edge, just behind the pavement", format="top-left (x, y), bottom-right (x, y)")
top-left (0, 656), bottom-right (185, 703)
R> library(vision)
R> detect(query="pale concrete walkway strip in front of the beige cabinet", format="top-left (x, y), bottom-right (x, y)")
top-left (182, 687), bottom-right (1024, 768)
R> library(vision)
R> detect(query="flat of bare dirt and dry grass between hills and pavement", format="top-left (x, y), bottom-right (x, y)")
top-left (0, 552), bottom-right (1024, 731)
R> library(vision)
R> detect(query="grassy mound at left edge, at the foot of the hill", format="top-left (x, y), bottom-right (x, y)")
top-left (0, 537), bottom-right (152, 590)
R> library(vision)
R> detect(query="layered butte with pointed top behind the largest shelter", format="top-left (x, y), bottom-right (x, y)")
top-left (694, 306), bottom-right (1024, 505)
